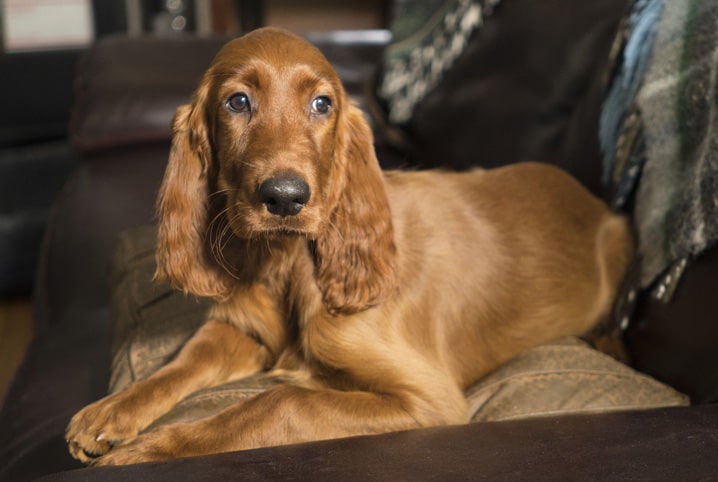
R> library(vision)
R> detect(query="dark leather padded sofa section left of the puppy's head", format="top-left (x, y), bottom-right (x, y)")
top-left (70, 36), bottom-right (227, 153)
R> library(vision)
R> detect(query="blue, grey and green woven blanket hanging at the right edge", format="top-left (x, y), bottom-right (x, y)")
top-left (600, 0), bottom-right (718, 300)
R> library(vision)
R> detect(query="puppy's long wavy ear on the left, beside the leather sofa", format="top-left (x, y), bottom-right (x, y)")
top-left (155, 79), bottom-right (229, 298)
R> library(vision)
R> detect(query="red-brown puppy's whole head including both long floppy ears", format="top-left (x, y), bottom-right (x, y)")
top-left (157, 28), bottom-right (396, 313)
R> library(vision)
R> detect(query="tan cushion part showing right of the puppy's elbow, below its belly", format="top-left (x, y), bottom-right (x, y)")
top-left (466, 337), bottom-right (688, 421)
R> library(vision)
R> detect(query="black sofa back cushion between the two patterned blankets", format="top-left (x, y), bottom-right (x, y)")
top-left (378, 0), bottom-right (627, 193)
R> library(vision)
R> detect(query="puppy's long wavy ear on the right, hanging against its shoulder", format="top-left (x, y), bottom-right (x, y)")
top-left (315, 105), bottom-right (397, 314)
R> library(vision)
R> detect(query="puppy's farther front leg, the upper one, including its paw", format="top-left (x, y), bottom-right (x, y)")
top-left (66, 321), bottom-right (268, 462)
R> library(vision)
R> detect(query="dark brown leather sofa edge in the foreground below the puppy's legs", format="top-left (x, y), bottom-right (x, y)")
top-left (41, 405), bottom-right (718, 482)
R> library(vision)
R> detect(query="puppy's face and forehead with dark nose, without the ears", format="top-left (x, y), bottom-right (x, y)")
top-left (205, 30), bottom-right (344, 238)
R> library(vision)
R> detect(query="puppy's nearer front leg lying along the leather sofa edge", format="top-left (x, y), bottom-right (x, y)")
top-left (97, 385), bottom-right (466, 465)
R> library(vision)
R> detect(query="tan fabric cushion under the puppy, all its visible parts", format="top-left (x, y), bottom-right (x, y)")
top-left (105, 226), bottom-right (688, 425)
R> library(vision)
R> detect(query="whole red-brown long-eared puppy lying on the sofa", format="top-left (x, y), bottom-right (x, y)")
top-left (67, 28), bottom-right (631, 464)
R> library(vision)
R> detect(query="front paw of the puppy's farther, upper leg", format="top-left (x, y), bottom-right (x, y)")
top-left (65, 392), bottom-right (152, 463)
